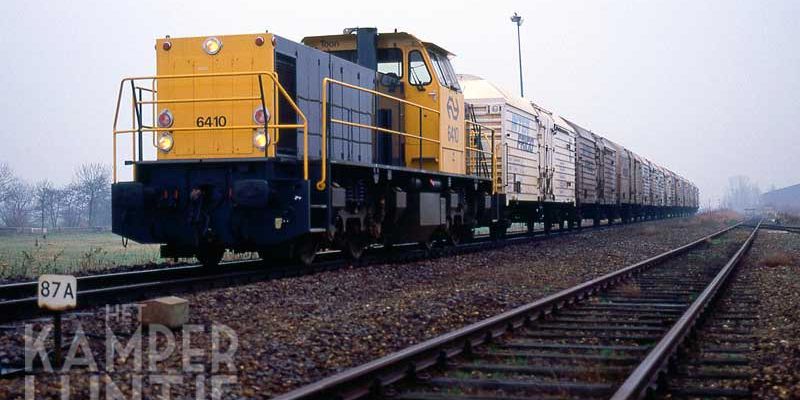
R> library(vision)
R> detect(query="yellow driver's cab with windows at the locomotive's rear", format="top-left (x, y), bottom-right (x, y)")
top-left (303, 28), bottom-right (466, 174)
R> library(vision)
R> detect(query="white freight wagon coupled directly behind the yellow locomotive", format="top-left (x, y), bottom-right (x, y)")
top-left (459, 75), bottom-right (575, 231)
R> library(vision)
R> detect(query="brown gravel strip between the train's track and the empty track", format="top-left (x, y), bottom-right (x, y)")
top-left (0, 215), bottom-right (731, 398)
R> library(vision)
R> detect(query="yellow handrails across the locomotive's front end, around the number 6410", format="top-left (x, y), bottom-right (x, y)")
top-left (112, 71), bottom-right (308, 182)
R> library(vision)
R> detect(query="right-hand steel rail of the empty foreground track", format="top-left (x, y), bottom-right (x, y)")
top-left (611, 222), bottom-right (761, 400)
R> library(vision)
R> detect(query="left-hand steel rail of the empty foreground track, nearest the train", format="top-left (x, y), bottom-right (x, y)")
top-left (274, 223), bottom-right (742, 400)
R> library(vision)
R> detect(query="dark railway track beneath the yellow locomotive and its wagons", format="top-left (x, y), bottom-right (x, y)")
top-left (0, 216), bottom-right (688, 324)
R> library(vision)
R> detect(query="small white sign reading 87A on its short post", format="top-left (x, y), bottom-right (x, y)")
top-left (36, 275), bottom-right (78, 367)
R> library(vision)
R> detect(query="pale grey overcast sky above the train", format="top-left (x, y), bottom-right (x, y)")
top-left (0, 0), bottom-right (800, 205)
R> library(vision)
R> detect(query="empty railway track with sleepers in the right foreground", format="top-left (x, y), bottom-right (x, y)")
top-left (276, 224), bottom-right (759, 400)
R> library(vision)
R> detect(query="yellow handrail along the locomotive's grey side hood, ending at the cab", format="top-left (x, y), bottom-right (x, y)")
top-left (316, 78), bottom-right (441, 191)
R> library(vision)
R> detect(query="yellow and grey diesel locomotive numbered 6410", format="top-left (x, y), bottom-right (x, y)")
top-left (112, 28), bottom-right (496, 265)
